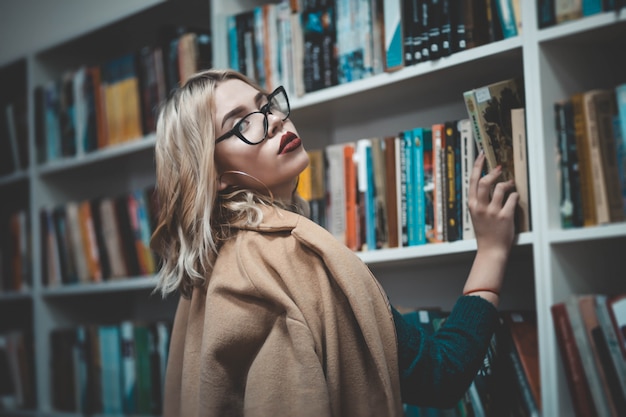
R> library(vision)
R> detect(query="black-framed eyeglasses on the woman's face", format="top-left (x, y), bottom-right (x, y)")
top-left (215, 86), bottom-right (291, 145)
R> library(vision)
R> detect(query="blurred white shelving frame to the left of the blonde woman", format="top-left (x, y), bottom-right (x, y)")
top-left (0, 0), bottom-right (210, 416)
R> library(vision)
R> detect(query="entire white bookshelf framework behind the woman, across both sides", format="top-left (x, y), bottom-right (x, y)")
top-left (0, 0), bottom-right (626, 416)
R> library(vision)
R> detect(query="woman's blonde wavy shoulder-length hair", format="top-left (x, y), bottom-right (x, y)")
top-left (150, 69), bottom-right (308, 297)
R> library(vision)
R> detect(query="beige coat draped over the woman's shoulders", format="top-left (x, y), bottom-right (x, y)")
top-left (164, 209), bottom-right (402, 417)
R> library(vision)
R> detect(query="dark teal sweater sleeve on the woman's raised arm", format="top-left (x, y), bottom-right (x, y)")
top-left (392, 296), bottom-right (498, 408)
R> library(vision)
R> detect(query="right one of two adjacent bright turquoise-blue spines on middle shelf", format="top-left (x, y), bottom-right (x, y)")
top-left (413, 127), bottom-right (432, 245)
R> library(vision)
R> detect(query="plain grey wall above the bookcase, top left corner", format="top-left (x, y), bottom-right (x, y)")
top-left (0, 0), bottom-right (163, 66)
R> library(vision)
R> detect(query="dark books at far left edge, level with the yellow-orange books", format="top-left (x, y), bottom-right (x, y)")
top-left (0, 96), bottom-right (29, 176)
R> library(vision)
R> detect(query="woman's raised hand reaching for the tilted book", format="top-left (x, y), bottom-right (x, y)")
top-left (468, 152), bottom-right (519, 258)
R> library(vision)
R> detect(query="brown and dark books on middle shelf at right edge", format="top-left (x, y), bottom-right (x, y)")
top-left (554, 84), bottom-right (626, 228)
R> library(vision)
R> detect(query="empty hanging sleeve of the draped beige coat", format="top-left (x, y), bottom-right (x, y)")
top-left (200, 232), bottom-right (331, 416)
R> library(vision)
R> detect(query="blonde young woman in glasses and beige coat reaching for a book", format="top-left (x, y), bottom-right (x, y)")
top-left (152, 70), bottom-right (518, 417)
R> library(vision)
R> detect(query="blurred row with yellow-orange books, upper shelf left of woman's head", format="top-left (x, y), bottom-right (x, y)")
top-left (34, 25), bottom-right (212, 163)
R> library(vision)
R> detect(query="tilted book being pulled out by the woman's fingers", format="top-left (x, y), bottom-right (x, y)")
top-left (463, 77), bottom-right (525, 181)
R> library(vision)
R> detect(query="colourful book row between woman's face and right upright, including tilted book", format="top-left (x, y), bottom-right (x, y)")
top-left (298, 79), bottom-right (530, 251)
